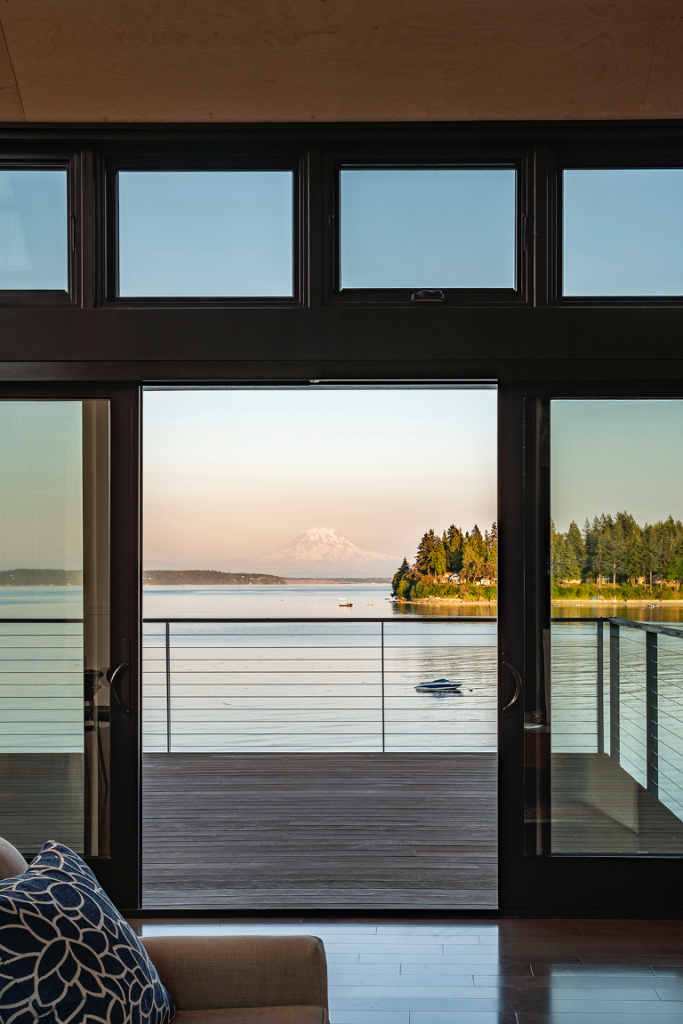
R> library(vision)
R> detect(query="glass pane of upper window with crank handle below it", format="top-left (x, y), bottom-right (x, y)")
top-left (340, 168), bottom-right (515, 288)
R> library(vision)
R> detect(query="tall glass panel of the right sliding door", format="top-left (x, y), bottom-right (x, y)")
top-left (548, 399), bottom-right (683, 856)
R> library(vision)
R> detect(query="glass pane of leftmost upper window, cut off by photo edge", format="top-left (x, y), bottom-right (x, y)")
top-left (0, 170), bottom-right (69, 291)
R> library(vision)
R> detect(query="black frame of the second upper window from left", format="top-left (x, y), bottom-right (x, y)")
top-left (96, 145), bottom-right (308, 308)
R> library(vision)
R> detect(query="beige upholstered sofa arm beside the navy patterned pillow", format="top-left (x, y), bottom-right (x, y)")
top-left (142, 935), bottom-right (328, 1011)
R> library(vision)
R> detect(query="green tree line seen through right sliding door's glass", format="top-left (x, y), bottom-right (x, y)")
top-left (551, 512), bottom-right (683, 590)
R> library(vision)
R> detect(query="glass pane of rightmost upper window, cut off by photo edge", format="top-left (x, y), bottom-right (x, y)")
top-left (562, 168), bottom-right (683, 296)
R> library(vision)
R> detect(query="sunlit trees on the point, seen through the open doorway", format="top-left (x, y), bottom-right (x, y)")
top-left (393, 523), bottom-right (498, 598)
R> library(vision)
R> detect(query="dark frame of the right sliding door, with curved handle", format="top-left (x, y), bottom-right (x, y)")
top-left (498, 377), bottom-right (683, 916)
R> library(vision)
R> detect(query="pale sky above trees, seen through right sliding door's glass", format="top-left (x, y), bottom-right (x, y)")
top-left (550, 398), bottom-right (683, 532)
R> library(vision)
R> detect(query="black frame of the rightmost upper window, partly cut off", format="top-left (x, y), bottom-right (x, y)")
top-left (548, 142), bottom-right (683, 307)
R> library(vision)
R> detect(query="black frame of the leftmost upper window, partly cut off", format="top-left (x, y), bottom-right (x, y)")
top-left (0, 145), bottom-right (82, 307)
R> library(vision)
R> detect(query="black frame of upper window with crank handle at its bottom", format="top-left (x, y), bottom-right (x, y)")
top-left (322, 139), bottom-right (532, 307)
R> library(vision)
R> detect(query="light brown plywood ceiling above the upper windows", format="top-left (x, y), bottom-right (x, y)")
top-left (0, 0), bottom-right (683, 122)
